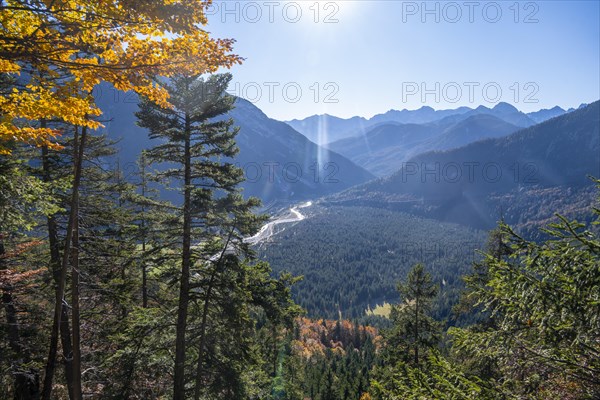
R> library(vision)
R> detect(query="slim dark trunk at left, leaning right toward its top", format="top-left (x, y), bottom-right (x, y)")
top-left (42, 127), bottom-right (87, 400)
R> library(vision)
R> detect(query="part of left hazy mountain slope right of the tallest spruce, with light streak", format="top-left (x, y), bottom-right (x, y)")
top-left (225, 99), bottom-right (374, 201)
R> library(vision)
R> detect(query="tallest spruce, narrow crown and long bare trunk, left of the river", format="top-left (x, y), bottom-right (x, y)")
top-left (136, 74), bottom-right (262, 399)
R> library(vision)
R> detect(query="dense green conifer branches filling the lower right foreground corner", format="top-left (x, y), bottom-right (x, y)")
top-left (449, 192), bottom-right (600, 398)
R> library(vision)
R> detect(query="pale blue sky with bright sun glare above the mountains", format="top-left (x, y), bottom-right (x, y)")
top-left (207, 0), bottom-right (600, 119)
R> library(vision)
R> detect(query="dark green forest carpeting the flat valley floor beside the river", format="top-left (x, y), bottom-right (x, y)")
top-left (257, 204), bottom-right (486, 320)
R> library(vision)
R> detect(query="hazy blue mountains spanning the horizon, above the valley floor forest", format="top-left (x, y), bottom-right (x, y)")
top-left (92, 83), bottom-right (600, 238)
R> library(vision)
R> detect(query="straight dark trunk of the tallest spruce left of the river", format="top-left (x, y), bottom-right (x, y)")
top-left (173, 114), bottom-right (192, 400)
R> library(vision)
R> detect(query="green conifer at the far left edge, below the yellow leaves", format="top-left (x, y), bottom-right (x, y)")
top-left (0, 155), bottom-right (58, 400)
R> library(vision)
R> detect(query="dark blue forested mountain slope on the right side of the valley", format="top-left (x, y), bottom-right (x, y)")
top-left (329, 102), bottom-right (600, 236)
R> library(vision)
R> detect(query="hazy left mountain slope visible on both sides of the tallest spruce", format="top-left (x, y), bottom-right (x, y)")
top-left (97, 86), bottom-right (374, 203)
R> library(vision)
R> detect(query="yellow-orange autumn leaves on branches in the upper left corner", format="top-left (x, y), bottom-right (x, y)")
top-left (0, 0), bottom-right (241, 153)
